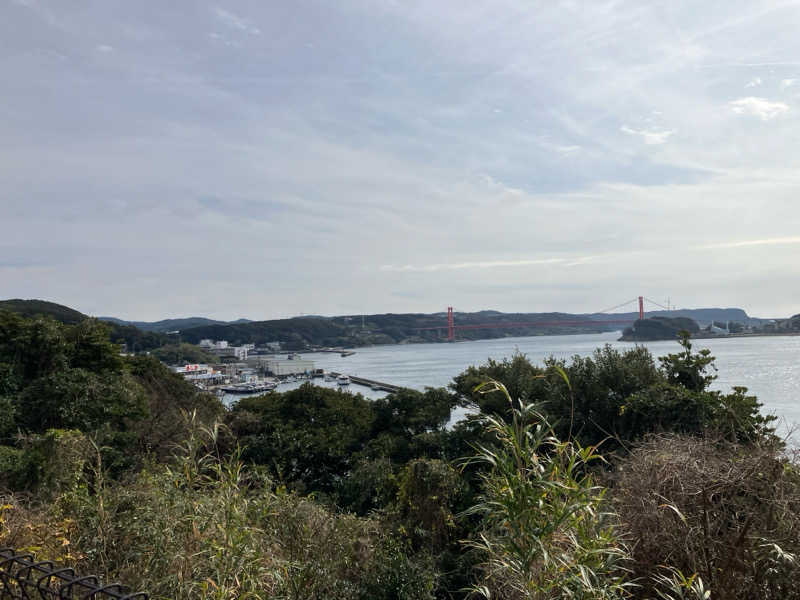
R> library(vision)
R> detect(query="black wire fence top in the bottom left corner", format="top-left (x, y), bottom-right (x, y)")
top-left (0, 548), bottom-right (148, 600)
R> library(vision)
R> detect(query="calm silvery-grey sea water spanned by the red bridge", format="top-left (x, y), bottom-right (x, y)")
top-left (272, 332), bottom-right (800, 440)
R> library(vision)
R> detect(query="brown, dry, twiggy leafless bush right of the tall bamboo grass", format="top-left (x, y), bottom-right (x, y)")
top-left (610, 435), bottom-right (800, 600)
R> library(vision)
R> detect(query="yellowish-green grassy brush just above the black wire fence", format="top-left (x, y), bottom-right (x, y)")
top-left (0, 422), bottom-right (436, 600)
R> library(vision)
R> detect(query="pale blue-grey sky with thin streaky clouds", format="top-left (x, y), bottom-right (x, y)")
top-left (0, 0), bottom-right (800, 320)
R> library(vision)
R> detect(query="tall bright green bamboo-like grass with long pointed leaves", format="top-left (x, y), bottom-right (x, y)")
top-left (465, 381), bottom-right (630, 600)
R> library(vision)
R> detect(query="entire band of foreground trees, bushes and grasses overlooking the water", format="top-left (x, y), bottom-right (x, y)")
top-left (0, 312), bottom-right (800, 600)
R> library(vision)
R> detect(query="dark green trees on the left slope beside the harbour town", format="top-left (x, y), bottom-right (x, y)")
top-left (0, 311), bottom-right (222, 490)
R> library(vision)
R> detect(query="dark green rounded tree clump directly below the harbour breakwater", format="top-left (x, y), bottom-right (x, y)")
top-left (227, 384), bottom-right (454, 496)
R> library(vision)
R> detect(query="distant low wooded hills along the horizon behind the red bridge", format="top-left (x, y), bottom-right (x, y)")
top-left (0, 299), bottom-right (784, 351)
